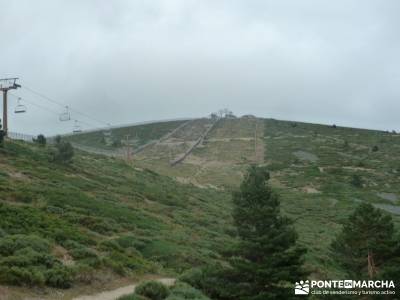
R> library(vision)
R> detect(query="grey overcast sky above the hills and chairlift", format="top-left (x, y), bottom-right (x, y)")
top-left (0, 0), bottom-right (400, 134)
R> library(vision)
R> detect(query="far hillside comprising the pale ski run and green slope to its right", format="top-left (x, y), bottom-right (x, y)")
top-left (67, 118), bottom-right (400, 278)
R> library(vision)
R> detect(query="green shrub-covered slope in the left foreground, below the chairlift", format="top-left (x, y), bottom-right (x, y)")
top-left (0, 142), bottom-right (230, 298)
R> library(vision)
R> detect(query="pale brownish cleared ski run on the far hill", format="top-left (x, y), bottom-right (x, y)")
top-left (135, 118), bottom-right (264, 189)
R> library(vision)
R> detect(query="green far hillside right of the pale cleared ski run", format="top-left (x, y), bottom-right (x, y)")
top-left (265, 120), bottom-right (400, 278)
